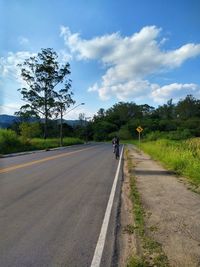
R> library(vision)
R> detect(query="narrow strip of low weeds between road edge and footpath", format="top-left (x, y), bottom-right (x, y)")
top-left (124, 148), bottom-right (169, 267)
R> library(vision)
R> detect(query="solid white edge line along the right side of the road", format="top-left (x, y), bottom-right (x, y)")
top-left (91, 147), bottom-right (124, 267)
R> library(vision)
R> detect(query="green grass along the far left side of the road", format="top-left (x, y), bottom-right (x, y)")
top-left (0, 129), bottom-right (83, 154)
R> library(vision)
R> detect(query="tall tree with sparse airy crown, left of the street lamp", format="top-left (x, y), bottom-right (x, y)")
top-left (18, 48), bottom-right (74, 138)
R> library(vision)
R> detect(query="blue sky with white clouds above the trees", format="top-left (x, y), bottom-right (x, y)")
top-left (0, 0), bottom-right (200, 119)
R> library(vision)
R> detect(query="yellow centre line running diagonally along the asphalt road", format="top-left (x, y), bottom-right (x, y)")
top-left (0, 147), bottom-right (93, 176)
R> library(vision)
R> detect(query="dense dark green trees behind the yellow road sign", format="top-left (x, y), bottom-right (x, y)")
top-left (92, 95), bottom-right (200, 140)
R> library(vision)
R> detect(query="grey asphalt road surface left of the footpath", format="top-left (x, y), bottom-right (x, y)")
top-left (0, 144), bottom-right (120, 267)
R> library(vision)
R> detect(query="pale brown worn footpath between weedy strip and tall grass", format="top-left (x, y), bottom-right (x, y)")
top-left (121, 145), bottom-right (200, 267)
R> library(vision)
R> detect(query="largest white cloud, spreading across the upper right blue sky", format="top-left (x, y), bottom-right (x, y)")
top-left (60, 26), bottom-right (200, 101)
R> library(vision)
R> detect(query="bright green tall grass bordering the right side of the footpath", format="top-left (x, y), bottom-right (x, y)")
top-left (141, 138), bottom-right (200, 185)
